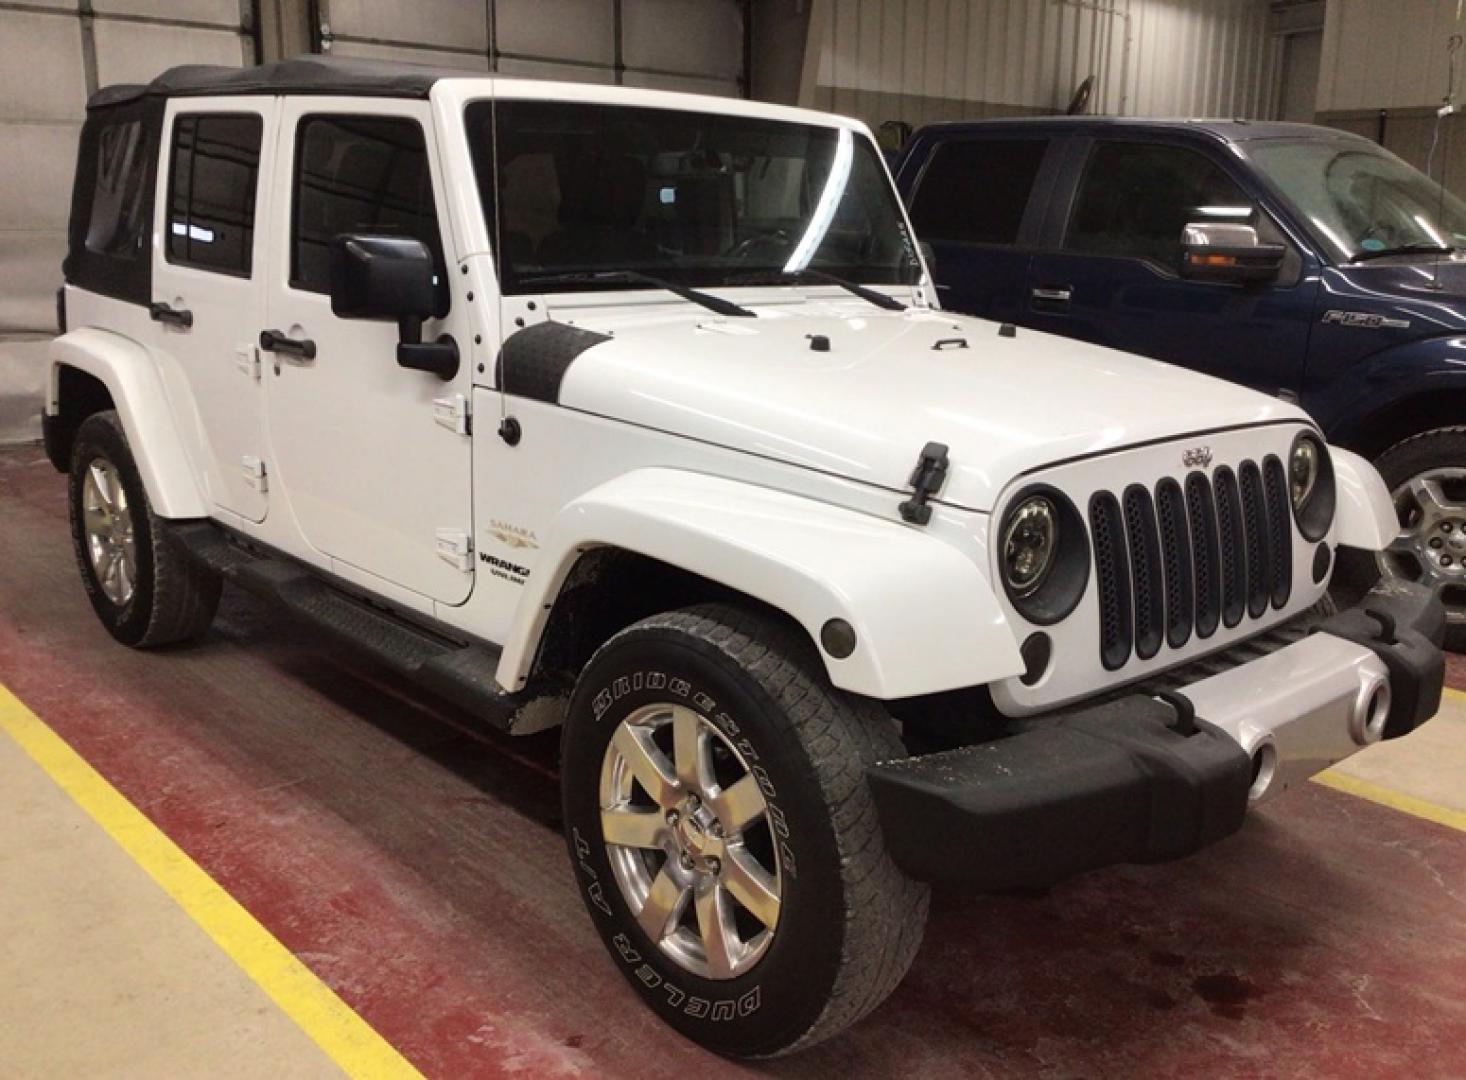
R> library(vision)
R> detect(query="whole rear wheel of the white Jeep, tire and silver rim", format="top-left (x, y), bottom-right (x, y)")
top-left (70, 409), bottom-right (221, 648)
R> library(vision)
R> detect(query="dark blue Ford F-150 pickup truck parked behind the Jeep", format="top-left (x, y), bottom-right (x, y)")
top-left (896, 117), bottom-right (1466, 649)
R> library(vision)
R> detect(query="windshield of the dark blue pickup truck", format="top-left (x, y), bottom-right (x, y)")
top-left (1243, 139), bottom-right (1466, 262)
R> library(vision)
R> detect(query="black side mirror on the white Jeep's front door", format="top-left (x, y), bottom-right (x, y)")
top-left (331, 233), bottom-right (459, 380)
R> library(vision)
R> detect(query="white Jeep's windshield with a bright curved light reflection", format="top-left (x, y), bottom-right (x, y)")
top-left (466, 101), bottom-right (919, 293)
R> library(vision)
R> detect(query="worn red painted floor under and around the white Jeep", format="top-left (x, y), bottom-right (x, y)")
top-left (0, 450), bottom-right (1466, 1077)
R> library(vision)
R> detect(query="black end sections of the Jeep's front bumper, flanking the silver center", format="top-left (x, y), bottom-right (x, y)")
top-left (866, 586), bottom-right (1445, 889)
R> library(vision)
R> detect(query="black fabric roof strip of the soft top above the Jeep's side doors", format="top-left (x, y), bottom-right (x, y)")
top-left (86, 56), bottom-right (463, 108)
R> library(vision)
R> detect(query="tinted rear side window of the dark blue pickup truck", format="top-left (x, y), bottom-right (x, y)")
top-left (912, 139), bottom-right (1048, 243)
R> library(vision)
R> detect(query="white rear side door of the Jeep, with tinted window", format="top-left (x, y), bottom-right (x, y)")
top-left (150, 97), bottom-right (280, 523)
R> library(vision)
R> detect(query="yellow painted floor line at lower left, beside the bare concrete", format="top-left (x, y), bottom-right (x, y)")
top-left (0, 686), bottom-right (422, 1080)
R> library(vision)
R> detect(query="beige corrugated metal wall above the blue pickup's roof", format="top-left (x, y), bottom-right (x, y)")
top-left (802, 0), bottom-right (1281, 126)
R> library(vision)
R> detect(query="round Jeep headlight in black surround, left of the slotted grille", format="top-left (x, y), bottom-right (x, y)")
top-left (997, 484), bottom-right (1089, 626)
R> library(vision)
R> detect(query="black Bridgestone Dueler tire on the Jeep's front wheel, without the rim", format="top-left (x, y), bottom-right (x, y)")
top-left (561, 604), bottom-right (928, 1057)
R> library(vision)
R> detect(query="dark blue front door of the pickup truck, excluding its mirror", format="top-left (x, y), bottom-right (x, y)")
top-left (1020, 136), bottom-right (1318, 394)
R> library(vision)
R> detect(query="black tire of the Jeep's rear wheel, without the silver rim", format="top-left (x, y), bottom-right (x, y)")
top-left (67, 409), bottom-right (223, 649)
